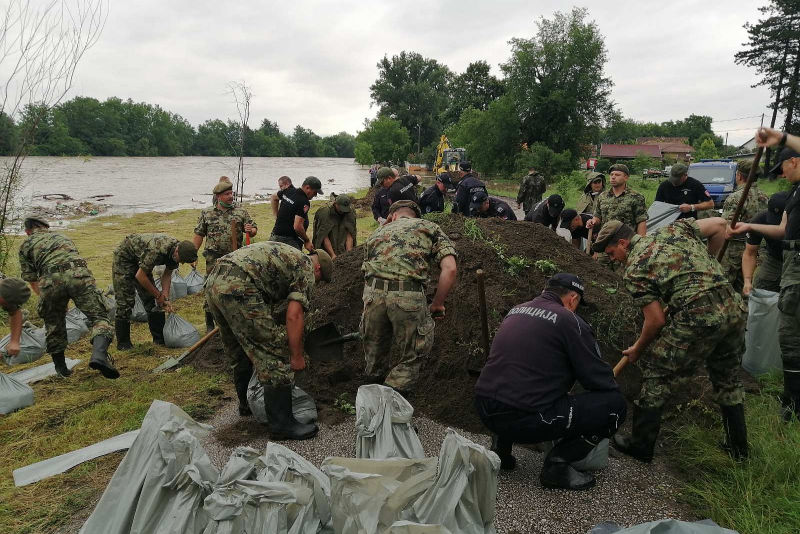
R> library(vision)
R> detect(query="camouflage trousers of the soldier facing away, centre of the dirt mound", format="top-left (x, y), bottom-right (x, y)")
top-left (359, 285), bottom-right (435, 391)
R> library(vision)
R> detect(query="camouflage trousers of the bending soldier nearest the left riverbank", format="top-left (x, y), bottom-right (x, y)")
top-left (38, 269), bottom-right (114, 354)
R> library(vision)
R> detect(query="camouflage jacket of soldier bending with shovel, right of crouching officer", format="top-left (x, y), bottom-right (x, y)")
top-left (623, 219), bottom-right (729, 310)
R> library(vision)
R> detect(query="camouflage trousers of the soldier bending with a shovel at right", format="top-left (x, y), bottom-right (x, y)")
top-left (636, 289), bottom-right (745, 409)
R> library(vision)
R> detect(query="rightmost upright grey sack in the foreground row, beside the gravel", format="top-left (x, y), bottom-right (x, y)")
top-left (412, 428), bottom-right (500, 534)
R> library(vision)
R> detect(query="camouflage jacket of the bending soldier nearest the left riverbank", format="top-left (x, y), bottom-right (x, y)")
top-left (19, 230), bottom-right (91, 282)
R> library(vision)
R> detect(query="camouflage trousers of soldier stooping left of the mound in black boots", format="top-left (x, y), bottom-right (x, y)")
top-left (205, 262), bottom-right (294, 386)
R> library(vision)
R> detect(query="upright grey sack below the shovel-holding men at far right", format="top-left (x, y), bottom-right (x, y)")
top-left (742, 289), bottom-right (783, 376)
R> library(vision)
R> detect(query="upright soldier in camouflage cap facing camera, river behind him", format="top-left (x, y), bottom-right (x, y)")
top-left (192, 182), bottom-right (258, 332)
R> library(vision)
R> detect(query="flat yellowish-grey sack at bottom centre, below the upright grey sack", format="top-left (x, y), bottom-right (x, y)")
top-left (322, 457), bottom-right (438, 534)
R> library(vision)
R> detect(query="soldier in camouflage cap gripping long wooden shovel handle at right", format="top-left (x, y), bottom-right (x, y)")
top-left (722, 161), bottom-right (769, 293)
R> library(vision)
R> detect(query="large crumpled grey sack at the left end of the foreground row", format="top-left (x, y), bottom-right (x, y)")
top-left (80, 400), bottom-right (219, 534)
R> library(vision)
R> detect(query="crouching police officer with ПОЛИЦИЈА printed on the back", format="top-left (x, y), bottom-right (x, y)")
top-left (475, 273), bottom-right (627, 490)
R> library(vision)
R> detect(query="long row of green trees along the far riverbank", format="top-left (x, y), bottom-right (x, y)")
top-left (0, 97), bottom-right (355, 158)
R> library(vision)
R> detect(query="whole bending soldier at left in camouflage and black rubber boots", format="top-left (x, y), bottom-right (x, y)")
top-left (19, 217), bottom-right (119, 378)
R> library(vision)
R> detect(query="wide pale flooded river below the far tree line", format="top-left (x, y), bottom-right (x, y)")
top-left (7, 156), bottom-right (369, 219)
